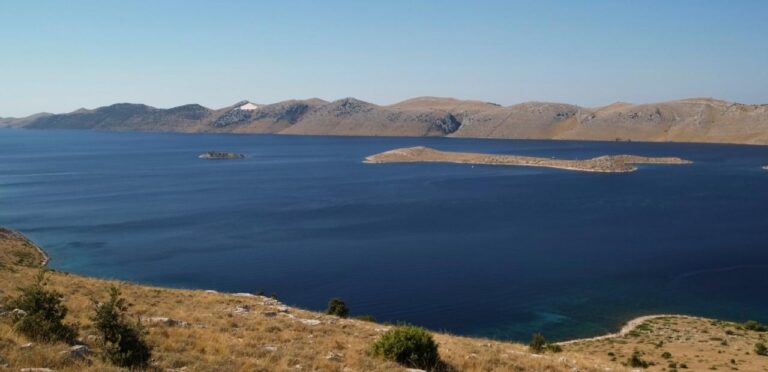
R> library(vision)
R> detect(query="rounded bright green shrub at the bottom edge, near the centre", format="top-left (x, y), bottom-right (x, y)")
top-left (372, 326), bottom-right (440, 369)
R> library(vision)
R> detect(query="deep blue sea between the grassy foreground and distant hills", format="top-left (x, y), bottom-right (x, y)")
top-left (0, 129), bottom-right (768, 340)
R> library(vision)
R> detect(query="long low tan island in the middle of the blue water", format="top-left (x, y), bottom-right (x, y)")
top-left (364, 146), bottom-right (692, 173)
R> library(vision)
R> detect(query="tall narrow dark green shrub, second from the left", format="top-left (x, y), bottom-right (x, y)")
top-left (91, 287), bottom-right (152, 368)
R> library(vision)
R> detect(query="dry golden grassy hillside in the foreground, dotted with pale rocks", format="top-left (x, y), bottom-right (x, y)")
top-left (0, 229), bottom-right (768, 371)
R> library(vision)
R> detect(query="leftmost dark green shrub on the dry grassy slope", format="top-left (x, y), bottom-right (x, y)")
top-left (8, 271), bottom-right (77, 343)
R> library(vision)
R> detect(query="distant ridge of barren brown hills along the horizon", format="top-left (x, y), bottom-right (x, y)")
top-left (6, 97), bottom-right (768, 145)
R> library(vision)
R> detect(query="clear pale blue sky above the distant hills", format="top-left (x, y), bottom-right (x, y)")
top-left (0, 0), bottom-right (768, 117)
